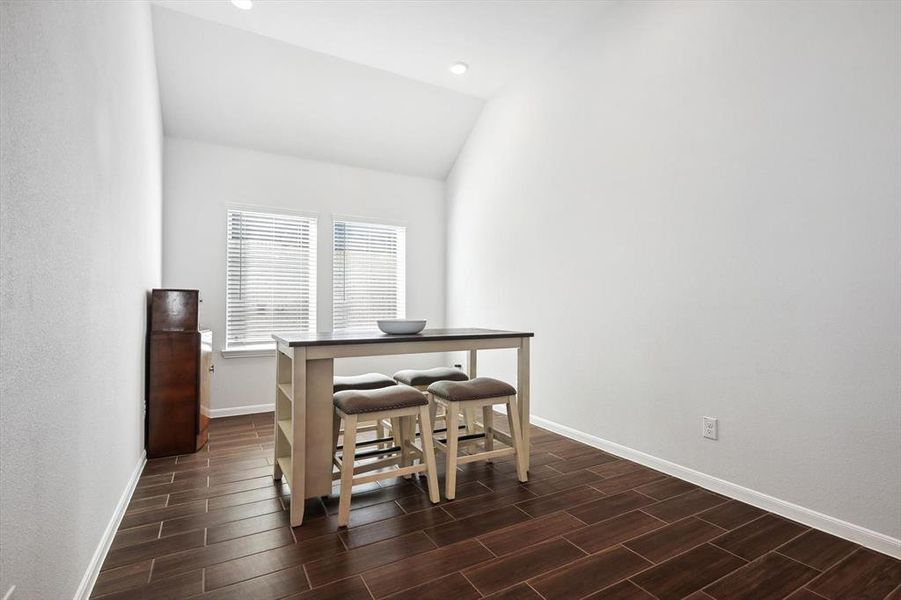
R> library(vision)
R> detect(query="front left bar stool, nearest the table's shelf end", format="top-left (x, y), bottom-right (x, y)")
top-left (332, 385), bottom-right (440, 527)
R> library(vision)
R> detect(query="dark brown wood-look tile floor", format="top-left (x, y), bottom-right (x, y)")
top-left (92, 413), bottom-right (901, 600)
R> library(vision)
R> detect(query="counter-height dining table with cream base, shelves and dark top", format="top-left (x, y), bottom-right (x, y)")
top-left (272, 328), bottom-right (534, 527)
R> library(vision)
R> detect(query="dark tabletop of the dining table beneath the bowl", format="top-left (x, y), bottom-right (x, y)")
top-left (272, 328), bottom-right (535, 347)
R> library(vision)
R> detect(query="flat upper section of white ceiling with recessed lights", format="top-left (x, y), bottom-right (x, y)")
top-left (156, 0), bottom-right (609, 98)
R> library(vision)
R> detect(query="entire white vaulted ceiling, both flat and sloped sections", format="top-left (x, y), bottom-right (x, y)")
top-left (153, 0), bottom-right (606, 180)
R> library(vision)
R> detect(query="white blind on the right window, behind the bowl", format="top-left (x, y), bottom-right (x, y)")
top-left (332, 220), bottom-right (407, 330)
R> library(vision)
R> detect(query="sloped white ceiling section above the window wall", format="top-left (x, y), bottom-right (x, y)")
top-left (153, 5), bottom-right (484, 180)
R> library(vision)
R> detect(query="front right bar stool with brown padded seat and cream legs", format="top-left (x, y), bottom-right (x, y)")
top-left (428, 377), bottom-right (528, 500)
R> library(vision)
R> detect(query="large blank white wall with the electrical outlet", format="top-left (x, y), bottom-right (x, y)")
top-left (448, 2), bottom-right (901, 538)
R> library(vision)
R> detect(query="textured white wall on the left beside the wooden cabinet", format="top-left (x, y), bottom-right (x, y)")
top-left (0, 2), bottom-right (161, 600)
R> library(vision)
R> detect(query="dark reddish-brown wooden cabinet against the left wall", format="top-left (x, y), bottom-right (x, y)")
top-left (146, 290), bottom-right (213, 458)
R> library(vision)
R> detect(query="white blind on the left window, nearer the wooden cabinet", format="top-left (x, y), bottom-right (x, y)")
top-left (226, 210), bottom-right (316, 348)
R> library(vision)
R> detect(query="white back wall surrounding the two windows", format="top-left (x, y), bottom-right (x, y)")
top-left (163, 137), bottom-right (446, 415)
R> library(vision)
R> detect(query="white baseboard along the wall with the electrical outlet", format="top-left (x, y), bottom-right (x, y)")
top-left (530, 415), bottom-right (901, 559)
